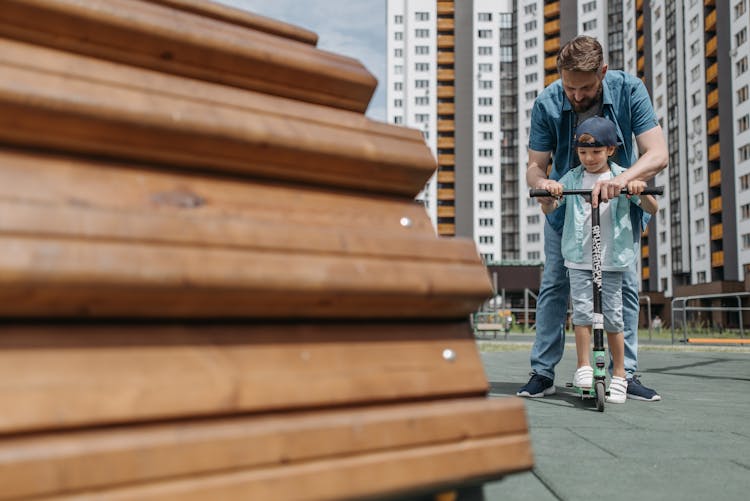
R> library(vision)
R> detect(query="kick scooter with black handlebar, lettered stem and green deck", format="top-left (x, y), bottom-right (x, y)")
top-left (529, 187), bottom-right (664, 412)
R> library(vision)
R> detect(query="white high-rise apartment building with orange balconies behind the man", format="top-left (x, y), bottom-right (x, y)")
top-left (386, 0), bottom-right (750, 308)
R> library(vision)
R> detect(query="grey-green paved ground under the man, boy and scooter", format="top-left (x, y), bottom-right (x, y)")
top-left (482, 341), bottom-right (750, 501)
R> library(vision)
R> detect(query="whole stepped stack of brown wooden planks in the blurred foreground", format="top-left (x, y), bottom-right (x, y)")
top-left (0, 0), bottom-right (532, 500)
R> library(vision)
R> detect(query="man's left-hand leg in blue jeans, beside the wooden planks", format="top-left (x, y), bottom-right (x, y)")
top-left (531, 221), bottom-right (570, 380)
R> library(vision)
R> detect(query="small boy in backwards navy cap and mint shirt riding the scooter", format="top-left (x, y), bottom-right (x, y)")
top-left (542, 117), bottom-right (658, 404)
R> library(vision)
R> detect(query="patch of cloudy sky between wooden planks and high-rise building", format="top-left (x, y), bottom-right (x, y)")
top-left (217, 0), bottom-right (386, 121)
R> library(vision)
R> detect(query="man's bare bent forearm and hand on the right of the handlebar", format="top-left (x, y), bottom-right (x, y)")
top-left (592, 125), bottom-right (669, 207)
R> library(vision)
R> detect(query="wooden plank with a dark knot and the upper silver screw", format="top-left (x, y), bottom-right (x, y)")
top-left (0, 148), bottom-right (464, 256)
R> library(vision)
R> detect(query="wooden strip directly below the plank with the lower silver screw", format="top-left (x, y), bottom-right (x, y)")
top-left (0, 398), bottom-right (528, 499)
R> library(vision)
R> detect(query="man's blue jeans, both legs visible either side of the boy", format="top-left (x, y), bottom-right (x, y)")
top-left (531, 221), bottom-right (640, 380)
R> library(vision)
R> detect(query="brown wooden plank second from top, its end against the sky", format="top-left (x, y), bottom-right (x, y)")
top-left (0, 0), bottom-right (377, 113)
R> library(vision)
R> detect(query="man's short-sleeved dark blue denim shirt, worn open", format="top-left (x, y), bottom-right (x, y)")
top-left (529, 70), bottom-right (659, 232)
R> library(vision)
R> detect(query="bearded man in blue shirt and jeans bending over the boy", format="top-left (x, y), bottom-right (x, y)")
top-left (516, 36), bottom-right (668, 402)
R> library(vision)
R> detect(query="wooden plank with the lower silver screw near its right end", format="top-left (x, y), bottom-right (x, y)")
top-left (0, 322), bottom-right (487, 434)
